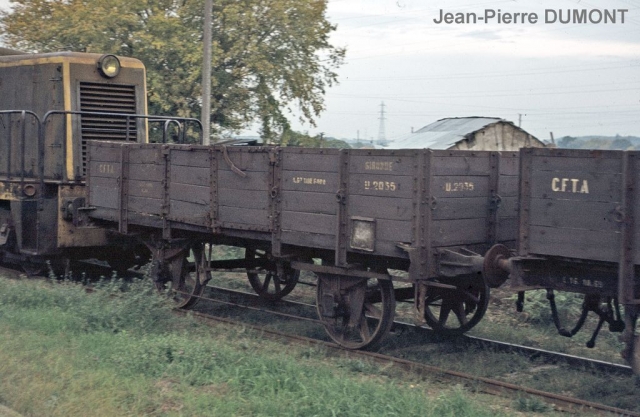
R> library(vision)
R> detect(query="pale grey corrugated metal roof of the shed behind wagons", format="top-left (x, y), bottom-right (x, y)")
top-left (387, 117), bottom-right (509, 149)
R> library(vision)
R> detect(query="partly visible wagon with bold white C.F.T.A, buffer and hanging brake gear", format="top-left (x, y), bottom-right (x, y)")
top-left (484, 149), bottom-right (640, 374)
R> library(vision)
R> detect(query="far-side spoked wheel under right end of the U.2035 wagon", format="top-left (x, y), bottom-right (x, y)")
top-left (424, 276), bottom-right (489, 335)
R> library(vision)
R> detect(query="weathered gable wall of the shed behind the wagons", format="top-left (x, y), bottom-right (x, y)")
top-left (449, 122), bottom-right (544, 151)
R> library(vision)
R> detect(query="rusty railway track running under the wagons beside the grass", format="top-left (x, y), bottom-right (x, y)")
top-left (0, 265), bottom-right (640, 417)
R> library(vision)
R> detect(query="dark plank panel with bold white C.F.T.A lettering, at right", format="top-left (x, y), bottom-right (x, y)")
top-left (519, 149), bottom-right (623, 262)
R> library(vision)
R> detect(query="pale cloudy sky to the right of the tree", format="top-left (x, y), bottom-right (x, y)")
top-left (0, 0), bottom-right (640, 140)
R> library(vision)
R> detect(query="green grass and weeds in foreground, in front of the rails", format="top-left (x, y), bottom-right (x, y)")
top-left (0, 279), bottom-right (510, 417)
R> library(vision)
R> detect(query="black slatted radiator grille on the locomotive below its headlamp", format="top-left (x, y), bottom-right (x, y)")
top-left (80, 82), bottom-right (137, 175)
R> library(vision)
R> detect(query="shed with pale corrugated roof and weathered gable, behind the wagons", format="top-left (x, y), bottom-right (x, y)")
top-left (387, 117), bottom-right (545, 151)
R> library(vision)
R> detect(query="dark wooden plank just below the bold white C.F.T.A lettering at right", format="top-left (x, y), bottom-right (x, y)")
top-left (530, 198), bottom-right (621, 232)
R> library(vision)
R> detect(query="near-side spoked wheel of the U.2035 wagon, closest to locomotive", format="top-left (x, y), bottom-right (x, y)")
top-left (152, 243), bottom-right (211, 308)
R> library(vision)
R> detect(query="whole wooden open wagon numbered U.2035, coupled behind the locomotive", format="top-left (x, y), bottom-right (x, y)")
top-left (83, 142), bottom-right (518, 348)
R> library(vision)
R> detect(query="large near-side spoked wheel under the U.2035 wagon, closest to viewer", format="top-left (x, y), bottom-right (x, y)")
top-left (316, 275), bottom-right (396, 349)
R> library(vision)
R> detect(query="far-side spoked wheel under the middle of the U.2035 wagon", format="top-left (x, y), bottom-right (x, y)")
top-left (244, 248), bottom-right (300, 301)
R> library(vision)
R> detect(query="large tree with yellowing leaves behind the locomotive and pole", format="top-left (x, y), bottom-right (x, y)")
top-left (0, 0), bottom-right (345, 139)
